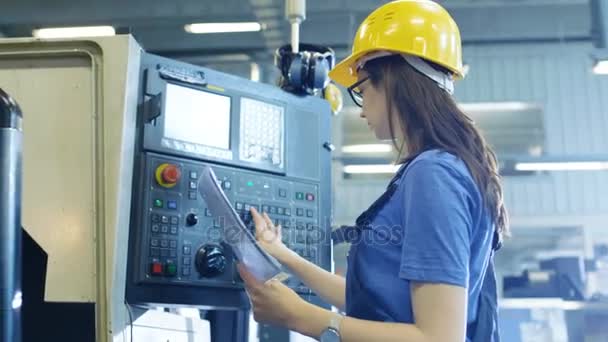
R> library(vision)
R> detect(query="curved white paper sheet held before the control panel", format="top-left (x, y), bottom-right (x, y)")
top-left (198, 166), bottom-right (289, 282)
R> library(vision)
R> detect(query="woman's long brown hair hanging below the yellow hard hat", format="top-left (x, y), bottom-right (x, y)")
top-left (364, 55), bottom-right (509, 236)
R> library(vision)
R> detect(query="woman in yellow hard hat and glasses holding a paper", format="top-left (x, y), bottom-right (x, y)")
top-left (239, 0), bottom-right (507, 342)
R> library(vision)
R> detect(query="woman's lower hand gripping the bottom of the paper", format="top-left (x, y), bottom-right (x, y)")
top-left (237, 264), bottom-right (306, 330)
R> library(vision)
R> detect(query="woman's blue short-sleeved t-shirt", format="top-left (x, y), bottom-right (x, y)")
top-left (346, 150), bottom-right (494, 340)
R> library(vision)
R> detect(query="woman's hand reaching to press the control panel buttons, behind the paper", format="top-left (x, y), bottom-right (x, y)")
top-left (251, 208), bottom-right (294, 263)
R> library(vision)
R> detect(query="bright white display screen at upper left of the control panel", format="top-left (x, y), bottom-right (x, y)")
top-left (164, 84), bottom-right (231, 150)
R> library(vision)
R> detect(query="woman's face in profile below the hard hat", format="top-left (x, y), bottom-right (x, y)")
top-left (358, 70), bottom-right (401, 140)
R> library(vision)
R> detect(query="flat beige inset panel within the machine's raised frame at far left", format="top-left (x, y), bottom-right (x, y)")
top-left (0, 56), bottom-right (97, 302)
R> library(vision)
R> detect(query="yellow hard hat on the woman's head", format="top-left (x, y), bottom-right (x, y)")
top-left (329, 0), bottom-right (464, 87)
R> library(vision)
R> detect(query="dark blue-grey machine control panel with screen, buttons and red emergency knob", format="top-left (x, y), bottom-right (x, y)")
top-left (127, 55), bottom-right (331, 308)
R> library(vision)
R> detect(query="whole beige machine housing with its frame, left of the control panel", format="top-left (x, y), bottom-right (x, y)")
top-left (0, 36), bottom-right (142, 342)
